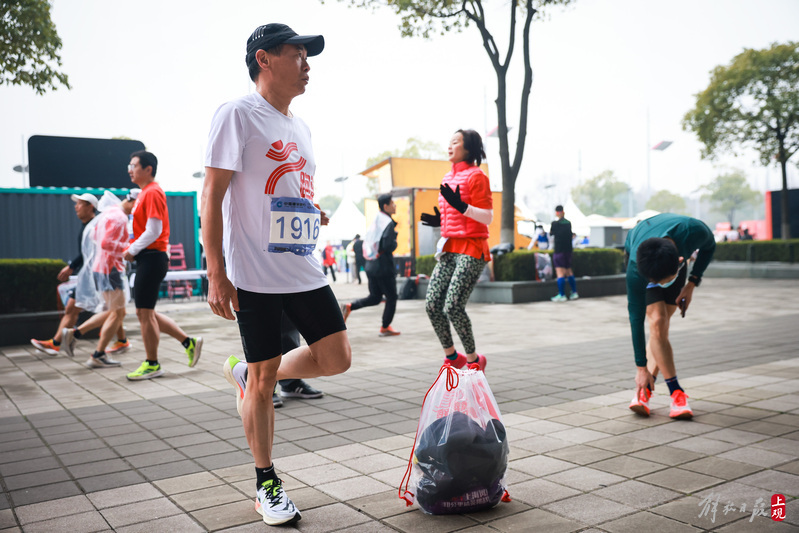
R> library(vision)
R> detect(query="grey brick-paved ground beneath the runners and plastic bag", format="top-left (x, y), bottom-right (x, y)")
top-left (0, 279), bottom-right (799, 533)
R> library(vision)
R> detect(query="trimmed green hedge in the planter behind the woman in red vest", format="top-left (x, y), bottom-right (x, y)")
top-left (416, 248), bottom-right (624, 281)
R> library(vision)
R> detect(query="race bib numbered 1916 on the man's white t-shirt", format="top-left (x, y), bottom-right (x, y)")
top-left (267, 197), bottom-right (321, 255)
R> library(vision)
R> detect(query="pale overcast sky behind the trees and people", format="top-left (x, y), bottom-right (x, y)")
top-left (0, 0), bottom-right (799, 212)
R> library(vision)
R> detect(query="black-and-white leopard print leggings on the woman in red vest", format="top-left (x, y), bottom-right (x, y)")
top-left (425, 253), bottom-right (486, 354)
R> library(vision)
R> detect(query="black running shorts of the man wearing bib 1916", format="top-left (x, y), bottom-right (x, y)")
top-left (236, 282), bottom-right (347, 363)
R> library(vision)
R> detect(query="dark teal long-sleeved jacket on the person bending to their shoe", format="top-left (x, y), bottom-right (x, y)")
top-left (624, 213), bottom-right (716, 366)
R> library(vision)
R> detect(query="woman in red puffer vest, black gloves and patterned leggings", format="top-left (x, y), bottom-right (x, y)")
top-left (422, 130), bottom-right (494, 370)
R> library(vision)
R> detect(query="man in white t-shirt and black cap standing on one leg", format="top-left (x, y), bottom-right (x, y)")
top-left (202, 24), bottom-right (351, 525)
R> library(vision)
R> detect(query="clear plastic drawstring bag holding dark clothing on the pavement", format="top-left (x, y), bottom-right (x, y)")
top-left (399, 364), bottom-right (510, 515)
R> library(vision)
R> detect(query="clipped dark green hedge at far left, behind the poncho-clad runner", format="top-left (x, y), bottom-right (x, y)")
top-left (0, 259), bottom-right (66, 314)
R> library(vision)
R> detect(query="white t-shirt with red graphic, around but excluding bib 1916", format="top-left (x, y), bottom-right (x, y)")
top-left (205, 93), bottom-right (328, 294)
